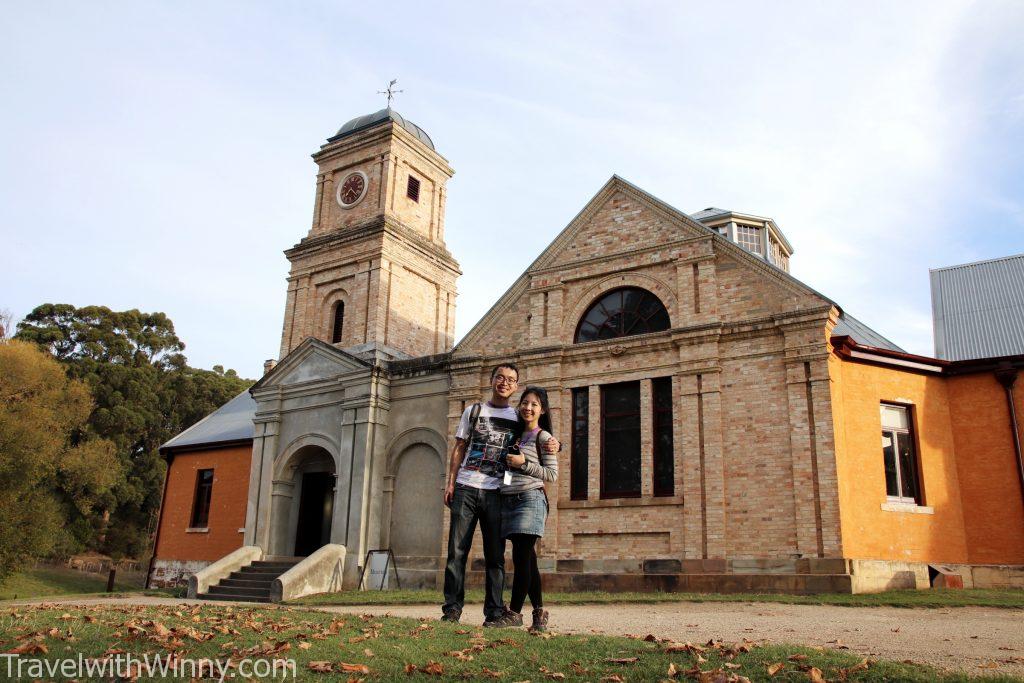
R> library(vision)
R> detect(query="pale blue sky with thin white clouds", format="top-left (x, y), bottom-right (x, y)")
top-left (0, 0), bottom-right (1024, 378)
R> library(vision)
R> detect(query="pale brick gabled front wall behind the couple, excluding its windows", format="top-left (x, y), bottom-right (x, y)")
top-left (450, 180), bottom-right (842, 559)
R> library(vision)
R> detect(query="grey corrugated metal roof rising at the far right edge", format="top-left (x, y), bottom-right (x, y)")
top-left (929, 254), bottom-right (1024, 360)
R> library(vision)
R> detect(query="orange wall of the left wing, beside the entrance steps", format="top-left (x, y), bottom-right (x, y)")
top-left (156, 445), bottom-right (252, 561)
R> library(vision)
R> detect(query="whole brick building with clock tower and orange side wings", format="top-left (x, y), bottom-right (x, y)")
top-left (151, 110), bottom-right (1024, 592)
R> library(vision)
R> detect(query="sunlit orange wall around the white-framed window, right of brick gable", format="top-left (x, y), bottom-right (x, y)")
top-left (829, 355), bottom-right (968, 563)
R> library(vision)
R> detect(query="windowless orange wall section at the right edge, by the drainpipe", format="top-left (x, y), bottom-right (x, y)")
top-left (946, 372), bottom-right (1024, 564)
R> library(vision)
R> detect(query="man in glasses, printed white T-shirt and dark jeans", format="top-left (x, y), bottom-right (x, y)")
top-left (441, 362), bottom-right (559, 626)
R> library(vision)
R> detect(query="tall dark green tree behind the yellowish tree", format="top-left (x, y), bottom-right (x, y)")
top-left (16, 304), bottom-right (252, 558)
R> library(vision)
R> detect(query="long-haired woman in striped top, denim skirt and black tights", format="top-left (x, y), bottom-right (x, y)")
top-left (494, 386), bottom-right (558, 631)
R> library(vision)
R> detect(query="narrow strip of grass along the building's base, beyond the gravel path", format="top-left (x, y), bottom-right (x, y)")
top-left (296, 589), bottom-right (1024, 609)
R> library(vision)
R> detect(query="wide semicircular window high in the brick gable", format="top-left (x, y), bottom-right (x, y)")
top-left (575, 287), bottom-right (671, 344)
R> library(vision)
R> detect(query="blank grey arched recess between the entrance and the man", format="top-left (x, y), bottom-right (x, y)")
top-left (390, 443), bottom-right (444, 566)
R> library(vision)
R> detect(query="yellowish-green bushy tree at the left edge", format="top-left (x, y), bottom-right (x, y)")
top-left (0, 340), bottom-right (122, 581)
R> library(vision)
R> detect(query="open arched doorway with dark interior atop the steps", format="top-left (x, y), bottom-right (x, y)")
top-left (270, 445), bottom-right (336, 557)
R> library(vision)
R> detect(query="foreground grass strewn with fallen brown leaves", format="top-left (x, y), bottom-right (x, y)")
top-left (0, 605), bottom-right (1020, 683)
